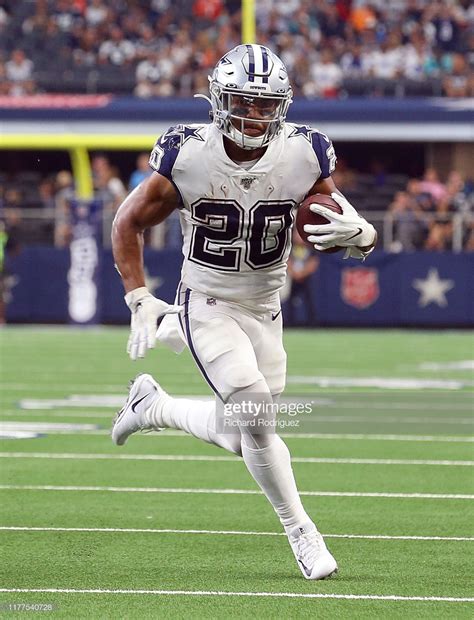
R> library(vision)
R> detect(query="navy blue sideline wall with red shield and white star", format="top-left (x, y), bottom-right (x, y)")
top-left (4, 247), bottom-right (474, 327)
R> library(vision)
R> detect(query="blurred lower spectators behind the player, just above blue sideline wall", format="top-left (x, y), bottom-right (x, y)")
top-left (0, 153), bottom-right (474, 252)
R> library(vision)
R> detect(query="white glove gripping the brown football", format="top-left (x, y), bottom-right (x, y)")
top-left (304, 192), bottom-right (376, 253)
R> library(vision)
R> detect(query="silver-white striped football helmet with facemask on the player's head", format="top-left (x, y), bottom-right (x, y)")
top-left (209, 45), bottom-right (293, 149)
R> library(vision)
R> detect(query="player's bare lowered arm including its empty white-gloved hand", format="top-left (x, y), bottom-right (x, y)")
top-left (112, 173), bottom-right (180, 359)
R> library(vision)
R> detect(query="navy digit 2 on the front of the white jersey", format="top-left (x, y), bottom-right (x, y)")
top-left (188, 200), bottom-right (243, 271)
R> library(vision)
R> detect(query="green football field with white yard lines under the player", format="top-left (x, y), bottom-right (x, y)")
top-left (0, 327), bottom-right (474, 619)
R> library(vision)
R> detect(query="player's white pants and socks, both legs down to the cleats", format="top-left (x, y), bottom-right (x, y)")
top-left (150, 285), bottom-right (310, 532)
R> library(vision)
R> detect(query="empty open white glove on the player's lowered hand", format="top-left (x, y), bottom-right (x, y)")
top-left (125, 286), bottom-right (183, 360)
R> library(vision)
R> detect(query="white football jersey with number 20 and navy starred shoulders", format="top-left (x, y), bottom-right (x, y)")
top-left (150, 123), bottom-right (336, 310)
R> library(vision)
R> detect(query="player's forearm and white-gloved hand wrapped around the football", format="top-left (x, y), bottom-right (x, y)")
top-left (305, 176), bottom-right (377, 259)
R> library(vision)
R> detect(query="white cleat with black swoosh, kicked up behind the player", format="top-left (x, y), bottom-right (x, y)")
top-left (112, 374), bottom-right (167, 446)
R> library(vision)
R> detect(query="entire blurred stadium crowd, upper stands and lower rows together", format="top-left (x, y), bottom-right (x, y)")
top-left (0, 0), bottom-right (474, 251)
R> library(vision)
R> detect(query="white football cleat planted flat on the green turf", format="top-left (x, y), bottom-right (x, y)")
top-left (288, 523), bottom-right (337, 579)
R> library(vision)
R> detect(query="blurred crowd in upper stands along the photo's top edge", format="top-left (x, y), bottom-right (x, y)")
top-left (0, 0), bottom-right (474, 98)
